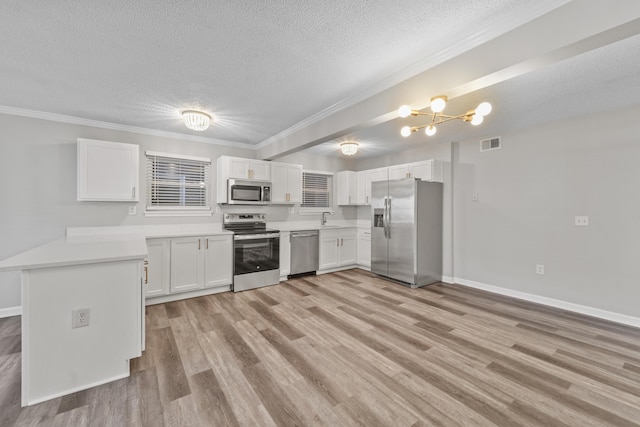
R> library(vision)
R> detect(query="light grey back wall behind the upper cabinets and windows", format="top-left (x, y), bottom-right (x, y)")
top-left (0, 114), bottom-right (356, 310)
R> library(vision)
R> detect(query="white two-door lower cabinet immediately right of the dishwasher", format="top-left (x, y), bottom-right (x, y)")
top-left (319, 228), bottom-right (357, 270)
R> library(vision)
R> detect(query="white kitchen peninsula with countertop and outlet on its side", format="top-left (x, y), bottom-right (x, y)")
top-left (0, 236), bottom-right (147, 406)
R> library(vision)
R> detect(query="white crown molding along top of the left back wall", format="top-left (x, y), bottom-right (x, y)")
top-left (0, 105), bottom-right (257, 150)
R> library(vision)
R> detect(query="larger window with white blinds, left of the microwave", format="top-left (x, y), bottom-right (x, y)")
top-left (146, 151), bottom-right (211, 213)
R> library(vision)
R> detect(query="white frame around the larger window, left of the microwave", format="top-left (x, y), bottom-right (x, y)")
top-left (144, 150), bottom-right (213, 216)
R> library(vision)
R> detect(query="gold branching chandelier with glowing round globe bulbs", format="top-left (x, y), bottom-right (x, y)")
top-left (398, 95), bottom-right (491, 137)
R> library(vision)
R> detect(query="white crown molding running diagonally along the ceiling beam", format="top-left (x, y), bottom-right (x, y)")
top-left (255, 0), bottom-right (571, 149)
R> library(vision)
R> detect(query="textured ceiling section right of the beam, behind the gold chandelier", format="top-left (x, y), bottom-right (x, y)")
top-left (305, 35), bottom-right (640, 159)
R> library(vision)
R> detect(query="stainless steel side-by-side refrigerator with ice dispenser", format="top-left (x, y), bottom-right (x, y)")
top-left (371, 178), bottom-right (442, 288)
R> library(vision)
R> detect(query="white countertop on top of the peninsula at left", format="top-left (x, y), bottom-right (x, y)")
top-left (0, 235), bottom-right (147, 271)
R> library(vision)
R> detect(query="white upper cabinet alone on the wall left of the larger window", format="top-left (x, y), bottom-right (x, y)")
top-left (77, 138), bottom-right (140, 202)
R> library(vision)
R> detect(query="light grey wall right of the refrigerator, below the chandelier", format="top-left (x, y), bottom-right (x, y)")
top-left (453, 107), bottom-right (640, 317)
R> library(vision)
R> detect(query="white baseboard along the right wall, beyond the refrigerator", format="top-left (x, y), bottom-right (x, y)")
top-left (456, 277), bottom-right (640, 328)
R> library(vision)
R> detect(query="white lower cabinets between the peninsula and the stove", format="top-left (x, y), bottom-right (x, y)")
top-left (146, 235), bottom-right (233, 298)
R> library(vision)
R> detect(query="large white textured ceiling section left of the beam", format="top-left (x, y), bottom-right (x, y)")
top-left (0, 0), bottom-right (552, 144)
